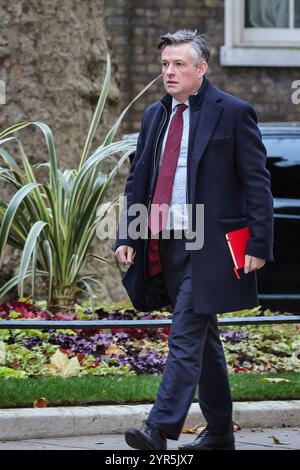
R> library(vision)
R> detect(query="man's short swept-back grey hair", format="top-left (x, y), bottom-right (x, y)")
top-left (158, 29), bottom-right (210, 63)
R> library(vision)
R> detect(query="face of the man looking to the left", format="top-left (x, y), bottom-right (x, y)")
top-left (161, 44), bottom-right (207, 101)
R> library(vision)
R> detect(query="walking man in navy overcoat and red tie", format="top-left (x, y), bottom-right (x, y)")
top-left (115, 30), bottom-right (273, 450)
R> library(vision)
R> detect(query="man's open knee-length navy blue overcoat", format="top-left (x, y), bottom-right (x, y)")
top-left (115, 78), bottom-right (274, 314)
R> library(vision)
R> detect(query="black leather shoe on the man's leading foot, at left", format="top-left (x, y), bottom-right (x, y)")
top-left (125, 420), bottom-right (167, 450)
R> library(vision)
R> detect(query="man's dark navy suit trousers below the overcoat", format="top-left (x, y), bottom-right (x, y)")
top-left (148, 232), bottom-right (232, 440)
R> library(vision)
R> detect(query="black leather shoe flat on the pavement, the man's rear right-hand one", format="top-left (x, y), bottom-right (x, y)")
top-left (179, 427), bottom-right (235, 450)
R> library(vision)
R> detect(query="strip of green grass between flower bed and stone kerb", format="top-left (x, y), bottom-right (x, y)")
top-left (0, 372), bottom-right (300, 408)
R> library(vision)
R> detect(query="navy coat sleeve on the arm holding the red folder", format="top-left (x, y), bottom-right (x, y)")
top-left (236, 103), bottom-right (274, 262)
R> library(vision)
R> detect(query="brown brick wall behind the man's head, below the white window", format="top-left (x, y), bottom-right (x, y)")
top-left (105, 0), bottom-right (300, 132)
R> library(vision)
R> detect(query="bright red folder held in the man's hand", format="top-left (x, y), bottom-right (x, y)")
top-left (225, 227), bottom-right (250, 279)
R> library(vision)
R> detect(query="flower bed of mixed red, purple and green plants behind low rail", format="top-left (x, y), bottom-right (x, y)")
top-left (0, 302), bottom-right (300, 378)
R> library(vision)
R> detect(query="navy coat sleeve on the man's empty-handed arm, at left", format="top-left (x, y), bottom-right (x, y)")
top-left (115, 113), bottom-right (145, 251)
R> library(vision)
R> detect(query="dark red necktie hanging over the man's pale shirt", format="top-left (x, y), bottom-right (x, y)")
top-left (148, 104), bottom-right (187, 275)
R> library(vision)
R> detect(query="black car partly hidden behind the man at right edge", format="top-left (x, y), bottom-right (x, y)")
top-left (258, 123), bottom-right (300, 313)
